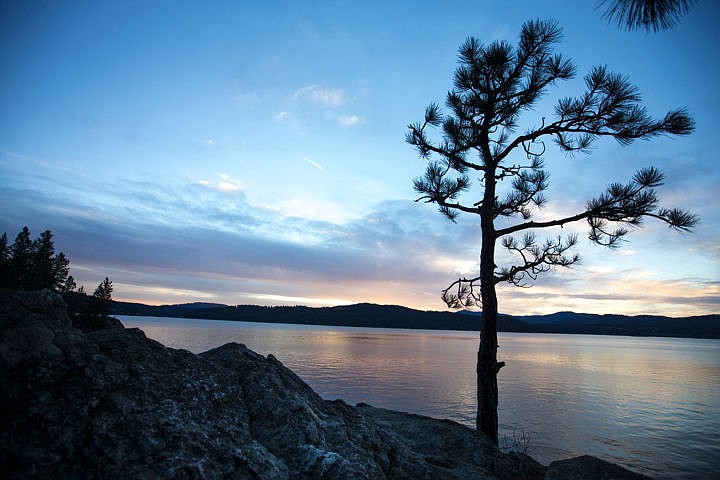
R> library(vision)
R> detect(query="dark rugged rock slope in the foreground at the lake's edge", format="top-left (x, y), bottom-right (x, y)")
top-left (0, 291), bottom-right (645, 479)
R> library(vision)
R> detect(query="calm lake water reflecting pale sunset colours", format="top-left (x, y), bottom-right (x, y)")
top-left (119, 316), bottom-right (720, 479)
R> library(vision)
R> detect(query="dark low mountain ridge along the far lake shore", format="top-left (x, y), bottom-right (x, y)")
top-left (111, 301), bottom-right (720, 338)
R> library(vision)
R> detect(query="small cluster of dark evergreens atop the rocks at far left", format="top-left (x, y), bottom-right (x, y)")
top-left (0, 226), bottom-right (113, 316)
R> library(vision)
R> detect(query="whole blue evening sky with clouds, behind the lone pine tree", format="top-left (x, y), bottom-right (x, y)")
top-left (0, 0), bottom-right (720, 316)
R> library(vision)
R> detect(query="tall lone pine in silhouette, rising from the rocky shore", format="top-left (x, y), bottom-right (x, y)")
top-left (407, 20), bottom-right (697, 443)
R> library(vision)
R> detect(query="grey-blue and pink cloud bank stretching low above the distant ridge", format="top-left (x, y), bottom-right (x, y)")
top-left (0, 156), bottom-right (720, 315)
